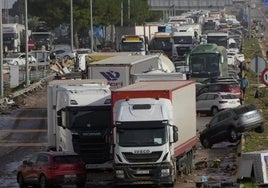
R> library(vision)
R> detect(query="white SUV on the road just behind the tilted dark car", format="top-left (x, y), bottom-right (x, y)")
top-left (196, 92), bottom-right (241, 115)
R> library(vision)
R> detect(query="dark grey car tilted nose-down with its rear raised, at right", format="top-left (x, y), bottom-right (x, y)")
top-left (199, 104), bottom-right (264, 148)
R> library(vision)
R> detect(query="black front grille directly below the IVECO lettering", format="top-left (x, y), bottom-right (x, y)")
top-left (123, 151), bottom-right (162, 163)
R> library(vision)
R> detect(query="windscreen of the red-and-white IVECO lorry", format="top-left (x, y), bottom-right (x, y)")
top-left (117, 127), bottom-right (167, 147)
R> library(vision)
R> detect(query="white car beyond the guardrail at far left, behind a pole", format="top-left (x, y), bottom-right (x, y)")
top-left (3, 53), bottom-right (37, 65)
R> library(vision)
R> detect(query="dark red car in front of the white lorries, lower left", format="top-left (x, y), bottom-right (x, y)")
top-left (17, 152), bottom-right (87, 188)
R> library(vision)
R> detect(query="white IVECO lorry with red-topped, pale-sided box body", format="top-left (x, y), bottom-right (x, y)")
top-left (112, 80), bottom-right (197, 186)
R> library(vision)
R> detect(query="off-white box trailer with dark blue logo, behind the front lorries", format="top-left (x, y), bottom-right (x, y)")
top-left (88, 55), bottom-right (175, 90)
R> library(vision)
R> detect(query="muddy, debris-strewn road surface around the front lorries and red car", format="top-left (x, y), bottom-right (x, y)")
top-left (0, 88), bottom-right (239, 188)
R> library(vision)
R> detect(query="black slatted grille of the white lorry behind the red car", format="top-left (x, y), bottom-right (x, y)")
top-left (73, 137), bottom-right (111, 164)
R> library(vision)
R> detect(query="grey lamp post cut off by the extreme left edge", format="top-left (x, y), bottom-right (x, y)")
top-left (0, 1), bottom-right (4, 98)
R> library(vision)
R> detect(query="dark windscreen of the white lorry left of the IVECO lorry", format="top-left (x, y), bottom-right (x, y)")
top-left (67, 110), bottom-right (112, 129)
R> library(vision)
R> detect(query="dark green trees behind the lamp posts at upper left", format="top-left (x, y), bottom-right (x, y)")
top-left (11, 0), bottom-right (161, 47)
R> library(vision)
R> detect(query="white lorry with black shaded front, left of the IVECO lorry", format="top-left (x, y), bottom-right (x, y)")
top-left (47, 79), bottom-right (113, 169)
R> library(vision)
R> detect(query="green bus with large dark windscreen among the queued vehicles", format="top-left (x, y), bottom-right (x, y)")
top-left (186, 44), bottom-right (228, 82)
